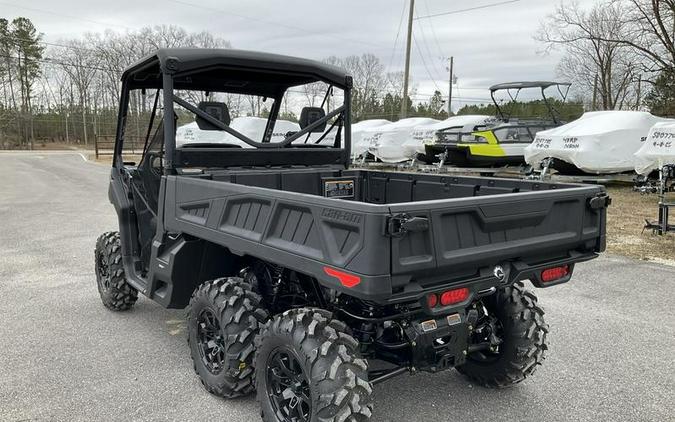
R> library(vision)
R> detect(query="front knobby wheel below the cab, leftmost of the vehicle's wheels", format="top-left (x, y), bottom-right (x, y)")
top-left (94, 232), bottom-right (138, 311)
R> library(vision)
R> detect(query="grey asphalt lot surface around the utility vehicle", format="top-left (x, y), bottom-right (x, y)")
top-left (0, 152), bottom-right (675, 422)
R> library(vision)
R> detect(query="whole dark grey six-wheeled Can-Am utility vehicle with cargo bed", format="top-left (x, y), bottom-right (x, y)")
top-left (96, 49), bottom-right (608, 421)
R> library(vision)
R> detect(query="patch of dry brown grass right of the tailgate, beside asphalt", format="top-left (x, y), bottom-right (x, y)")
top-left (607, 186), bottom-right (675, 265)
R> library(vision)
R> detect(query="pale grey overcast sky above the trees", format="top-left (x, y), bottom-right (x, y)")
top-left (5, 0), bottom-right (594, 109)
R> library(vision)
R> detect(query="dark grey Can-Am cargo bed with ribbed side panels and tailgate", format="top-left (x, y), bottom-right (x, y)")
top-left (165, 167), bottom-right (605, 301)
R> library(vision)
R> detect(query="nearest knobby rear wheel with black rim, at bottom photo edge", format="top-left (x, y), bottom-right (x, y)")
top-left (255, 308), bottom-right (373, 422)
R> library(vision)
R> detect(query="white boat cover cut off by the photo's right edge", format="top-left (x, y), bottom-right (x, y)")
top-left (635, 121), bottom-right (675, 174)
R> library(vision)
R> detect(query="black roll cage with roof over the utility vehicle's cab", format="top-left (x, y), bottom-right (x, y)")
top-left (113, 48), bottom-right (352, 174)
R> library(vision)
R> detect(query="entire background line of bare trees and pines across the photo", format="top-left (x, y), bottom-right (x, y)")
top-left (0, 0), bottom-right (675, 147)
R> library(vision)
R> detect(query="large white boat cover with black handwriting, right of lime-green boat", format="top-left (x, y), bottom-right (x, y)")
top-left (525, 111), bottom-right (668, 174)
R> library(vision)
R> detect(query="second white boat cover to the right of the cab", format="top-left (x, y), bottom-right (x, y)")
top-left (363, 117), bottom-right (438, 163)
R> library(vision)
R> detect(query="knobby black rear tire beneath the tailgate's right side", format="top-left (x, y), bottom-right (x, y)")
top-left (457, 282), bottom-right (548, 388)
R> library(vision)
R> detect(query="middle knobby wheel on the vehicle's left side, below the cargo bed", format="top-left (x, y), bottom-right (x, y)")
top-left (187, 277), bottom-right (268, 398)
